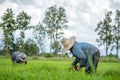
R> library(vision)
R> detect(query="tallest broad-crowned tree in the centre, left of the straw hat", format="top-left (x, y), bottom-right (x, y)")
top-left (43, 5), bottom-right (68, 54)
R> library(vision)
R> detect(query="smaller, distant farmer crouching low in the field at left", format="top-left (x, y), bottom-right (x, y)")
top-left (11, 51), bottom-right (27, 64)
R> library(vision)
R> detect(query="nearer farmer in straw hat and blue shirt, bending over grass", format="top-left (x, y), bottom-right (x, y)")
top-left (61, 36), bottom-right (100, 73)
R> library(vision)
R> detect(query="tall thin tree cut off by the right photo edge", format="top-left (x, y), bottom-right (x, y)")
top-left (113, 10), bottom-right (120, 57)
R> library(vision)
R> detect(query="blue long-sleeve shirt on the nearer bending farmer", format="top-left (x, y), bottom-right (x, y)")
top-left (71, 42), bottom-right (99, 68)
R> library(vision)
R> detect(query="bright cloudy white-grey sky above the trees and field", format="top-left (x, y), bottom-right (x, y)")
top-left (0, 0), bottom-right (120, 54)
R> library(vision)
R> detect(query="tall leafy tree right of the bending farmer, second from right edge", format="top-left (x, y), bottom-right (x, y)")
top-left (95, 11), bottom-right (112, 55)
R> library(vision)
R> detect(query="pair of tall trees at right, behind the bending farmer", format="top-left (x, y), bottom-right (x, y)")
top-left (95, 10), bottom-right (120, 57)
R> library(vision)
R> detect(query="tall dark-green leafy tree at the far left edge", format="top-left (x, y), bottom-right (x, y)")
top-left (0, 9), bottom-right (16, 54)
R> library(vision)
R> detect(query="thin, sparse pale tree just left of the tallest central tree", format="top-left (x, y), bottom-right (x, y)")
top-left (33, 22), bottom-right (46, 53)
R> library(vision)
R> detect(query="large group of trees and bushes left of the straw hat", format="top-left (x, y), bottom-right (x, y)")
top-left (0, 5), bottom-right (68, 55)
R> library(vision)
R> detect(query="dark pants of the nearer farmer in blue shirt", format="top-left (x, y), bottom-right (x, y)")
top-left (85, 51), bottom-right (100, 73)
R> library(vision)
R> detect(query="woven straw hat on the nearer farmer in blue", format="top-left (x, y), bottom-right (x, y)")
top-left (61, 36), bottom-right (76, 52)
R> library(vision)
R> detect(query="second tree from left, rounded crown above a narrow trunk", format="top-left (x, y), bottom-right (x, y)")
top-left (16, 11), bottom-right (31, 52)
